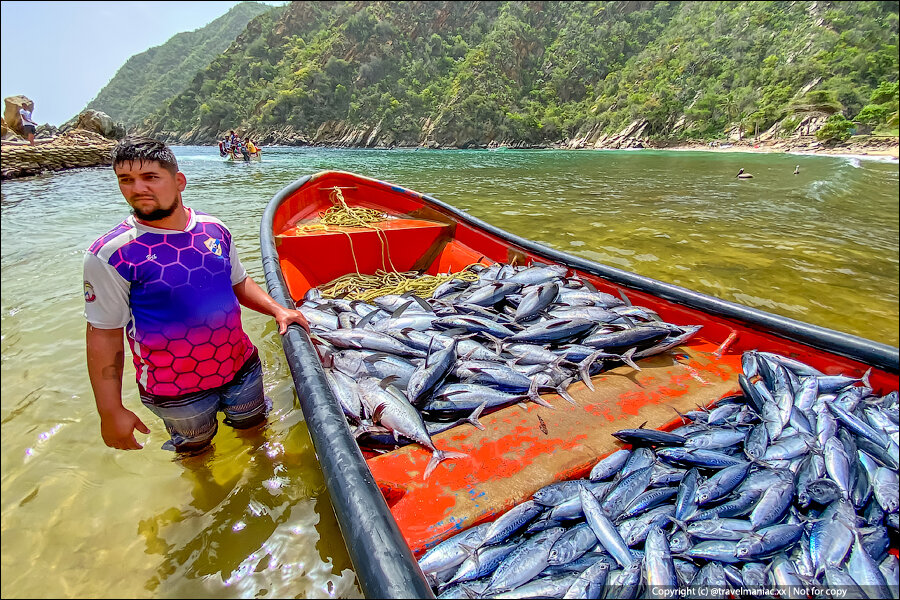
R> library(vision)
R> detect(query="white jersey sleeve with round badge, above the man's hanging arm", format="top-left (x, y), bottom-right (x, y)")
top-left (84, 252), bottom-right (130, 329)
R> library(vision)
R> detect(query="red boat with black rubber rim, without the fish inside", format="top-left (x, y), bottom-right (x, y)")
top-left (261, 171), bottom-right (900, 598)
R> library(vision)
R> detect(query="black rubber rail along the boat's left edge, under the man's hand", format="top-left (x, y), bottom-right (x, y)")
top-left (260, 177), bottom-right (434, 598)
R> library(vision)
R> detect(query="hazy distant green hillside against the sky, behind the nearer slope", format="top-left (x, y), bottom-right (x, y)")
top-left (86, 2), bottom-right (273, 127)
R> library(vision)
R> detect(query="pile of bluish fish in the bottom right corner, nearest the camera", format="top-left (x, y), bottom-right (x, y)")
top-left (419, 351), bottom-right (900, 598)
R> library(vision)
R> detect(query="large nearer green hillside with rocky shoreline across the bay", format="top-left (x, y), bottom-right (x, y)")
top-left (135, 1), bottom-right (898, 147)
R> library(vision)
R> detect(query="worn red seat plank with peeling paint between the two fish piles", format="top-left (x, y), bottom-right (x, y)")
top-left (368, 339), bottom-right (741, 554)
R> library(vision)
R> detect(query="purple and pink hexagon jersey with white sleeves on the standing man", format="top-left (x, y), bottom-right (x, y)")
top-left (84, 210), bottom-right (255, 396)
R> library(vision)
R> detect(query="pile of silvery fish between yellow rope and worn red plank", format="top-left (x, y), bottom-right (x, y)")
top-left (300, 263), bottom-right (700, 477)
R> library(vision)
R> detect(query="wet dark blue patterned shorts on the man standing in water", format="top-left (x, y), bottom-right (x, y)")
top-left (138, 351), bottom-right (269, 452)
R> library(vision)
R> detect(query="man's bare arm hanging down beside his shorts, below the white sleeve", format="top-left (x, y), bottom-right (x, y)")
top-left (86, 323), bottom-right (150, 450)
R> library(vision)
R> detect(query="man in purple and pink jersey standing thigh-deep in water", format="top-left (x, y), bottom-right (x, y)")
top-left (84, 137), bottom-right (309, 452)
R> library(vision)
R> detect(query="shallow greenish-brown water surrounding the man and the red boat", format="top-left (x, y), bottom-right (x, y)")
top-left (0, 147), bottom-right (900, 598)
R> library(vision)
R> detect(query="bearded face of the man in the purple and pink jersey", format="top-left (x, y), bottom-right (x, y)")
top-left (115, 160), bottom-right (187, 221)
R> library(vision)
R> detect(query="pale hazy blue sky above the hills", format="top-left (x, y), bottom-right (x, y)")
top-left (0, 1), bottom-right (284, 127)
